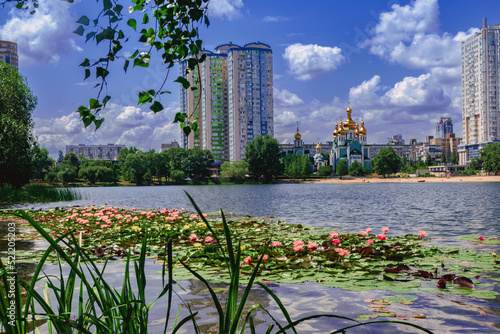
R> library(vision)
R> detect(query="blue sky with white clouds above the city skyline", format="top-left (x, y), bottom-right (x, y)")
top-left (0, 0), bottom-right (500, 156)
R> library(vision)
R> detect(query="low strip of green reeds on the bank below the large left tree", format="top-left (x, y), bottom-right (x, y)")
top-left (0, 184), bottom-right (81, 205)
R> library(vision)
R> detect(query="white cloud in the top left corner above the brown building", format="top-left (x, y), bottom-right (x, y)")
top-left (0, 0), bottom-right (81, 66)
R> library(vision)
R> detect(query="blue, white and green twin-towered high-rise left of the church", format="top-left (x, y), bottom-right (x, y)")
top-left (180, 42), bottom-right (274, 161)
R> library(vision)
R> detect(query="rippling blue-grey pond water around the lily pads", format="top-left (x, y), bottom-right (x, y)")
top-left (3, 183), bottom-right (500, 333)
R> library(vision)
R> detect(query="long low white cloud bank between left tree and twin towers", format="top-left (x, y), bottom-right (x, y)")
top-left (34, 103), bottom-right (184, 156)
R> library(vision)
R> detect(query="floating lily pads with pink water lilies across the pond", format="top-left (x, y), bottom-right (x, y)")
top-left (4, 206), bottom-right (500, 299)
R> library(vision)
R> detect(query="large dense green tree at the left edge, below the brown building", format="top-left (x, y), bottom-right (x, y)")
top-left (0, 62), bottom-right (37, 188)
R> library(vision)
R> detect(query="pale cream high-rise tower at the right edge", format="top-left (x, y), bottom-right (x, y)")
top-left (458, 19), bottom-right (500, 164)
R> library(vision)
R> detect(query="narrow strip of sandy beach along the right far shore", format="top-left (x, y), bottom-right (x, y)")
top-left (307, 175), bottom-right (500, 183)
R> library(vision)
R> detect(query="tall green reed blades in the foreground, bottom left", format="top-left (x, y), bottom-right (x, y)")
top-left (0, 194), bottom-right (432, 334)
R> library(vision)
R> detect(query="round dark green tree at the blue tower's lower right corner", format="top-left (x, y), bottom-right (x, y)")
top-left (245, 135), bottom-right (281, 183)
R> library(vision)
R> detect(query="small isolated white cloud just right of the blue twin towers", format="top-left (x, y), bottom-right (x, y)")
top-left (283, 43), bottom-right (345, 81)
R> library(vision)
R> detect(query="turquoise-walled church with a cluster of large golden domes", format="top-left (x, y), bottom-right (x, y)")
top-left (330, 106), bottom-right (372, 173)
